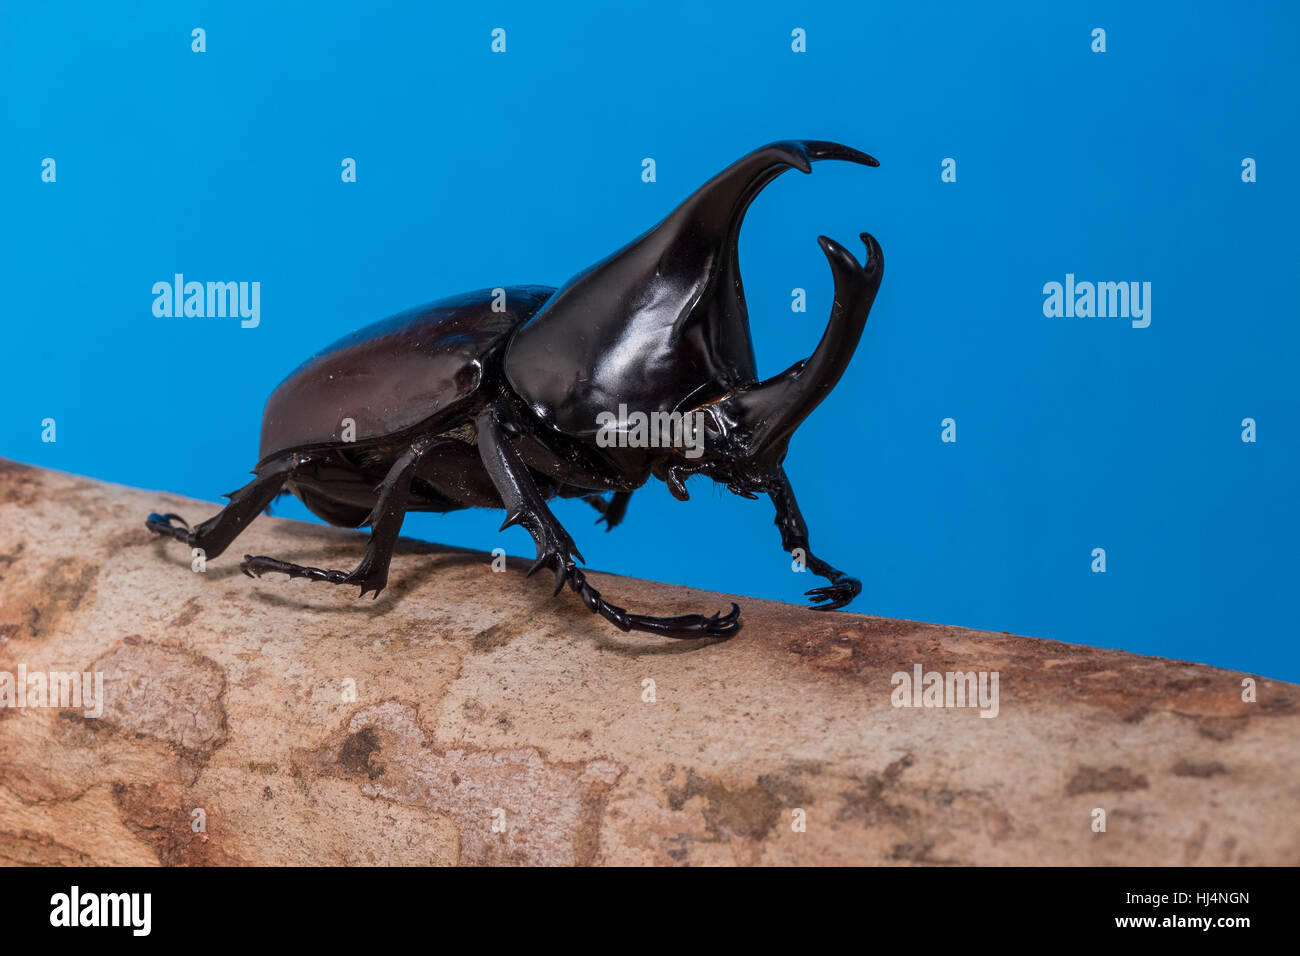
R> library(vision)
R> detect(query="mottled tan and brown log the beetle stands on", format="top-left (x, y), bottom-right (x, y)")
top-left (0, 462), bottom-right (1300, 865)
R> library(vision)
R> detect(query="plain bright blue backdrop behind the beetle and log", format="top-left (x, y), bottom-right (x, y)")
top-left (0, 1), bottom-right (1300, 680)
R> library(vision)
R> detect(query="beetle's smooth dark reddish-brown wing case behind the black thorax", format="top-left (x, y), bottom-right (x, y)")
top-left (259, 286), bottom-right (555, 460)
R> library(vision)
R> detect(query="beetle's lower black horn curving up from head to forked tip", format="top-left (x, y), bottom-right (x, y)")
top-left (742, 233), bottom-right (885, 455)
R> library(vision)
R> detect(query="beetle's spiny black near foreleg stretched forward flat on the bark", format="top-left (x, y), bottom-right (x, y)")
top-left (475, 406), bottom-right (740, 637)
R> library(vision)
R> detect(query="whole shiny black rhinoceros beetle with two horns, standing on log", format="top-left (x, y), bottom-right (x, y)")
top-left (147, 140), bottom-right (884, 637)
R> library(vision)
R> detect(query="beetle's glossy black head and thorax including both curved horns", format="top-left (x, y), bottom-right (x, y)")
top-left (503, 140), bottom-right (880, 455)
